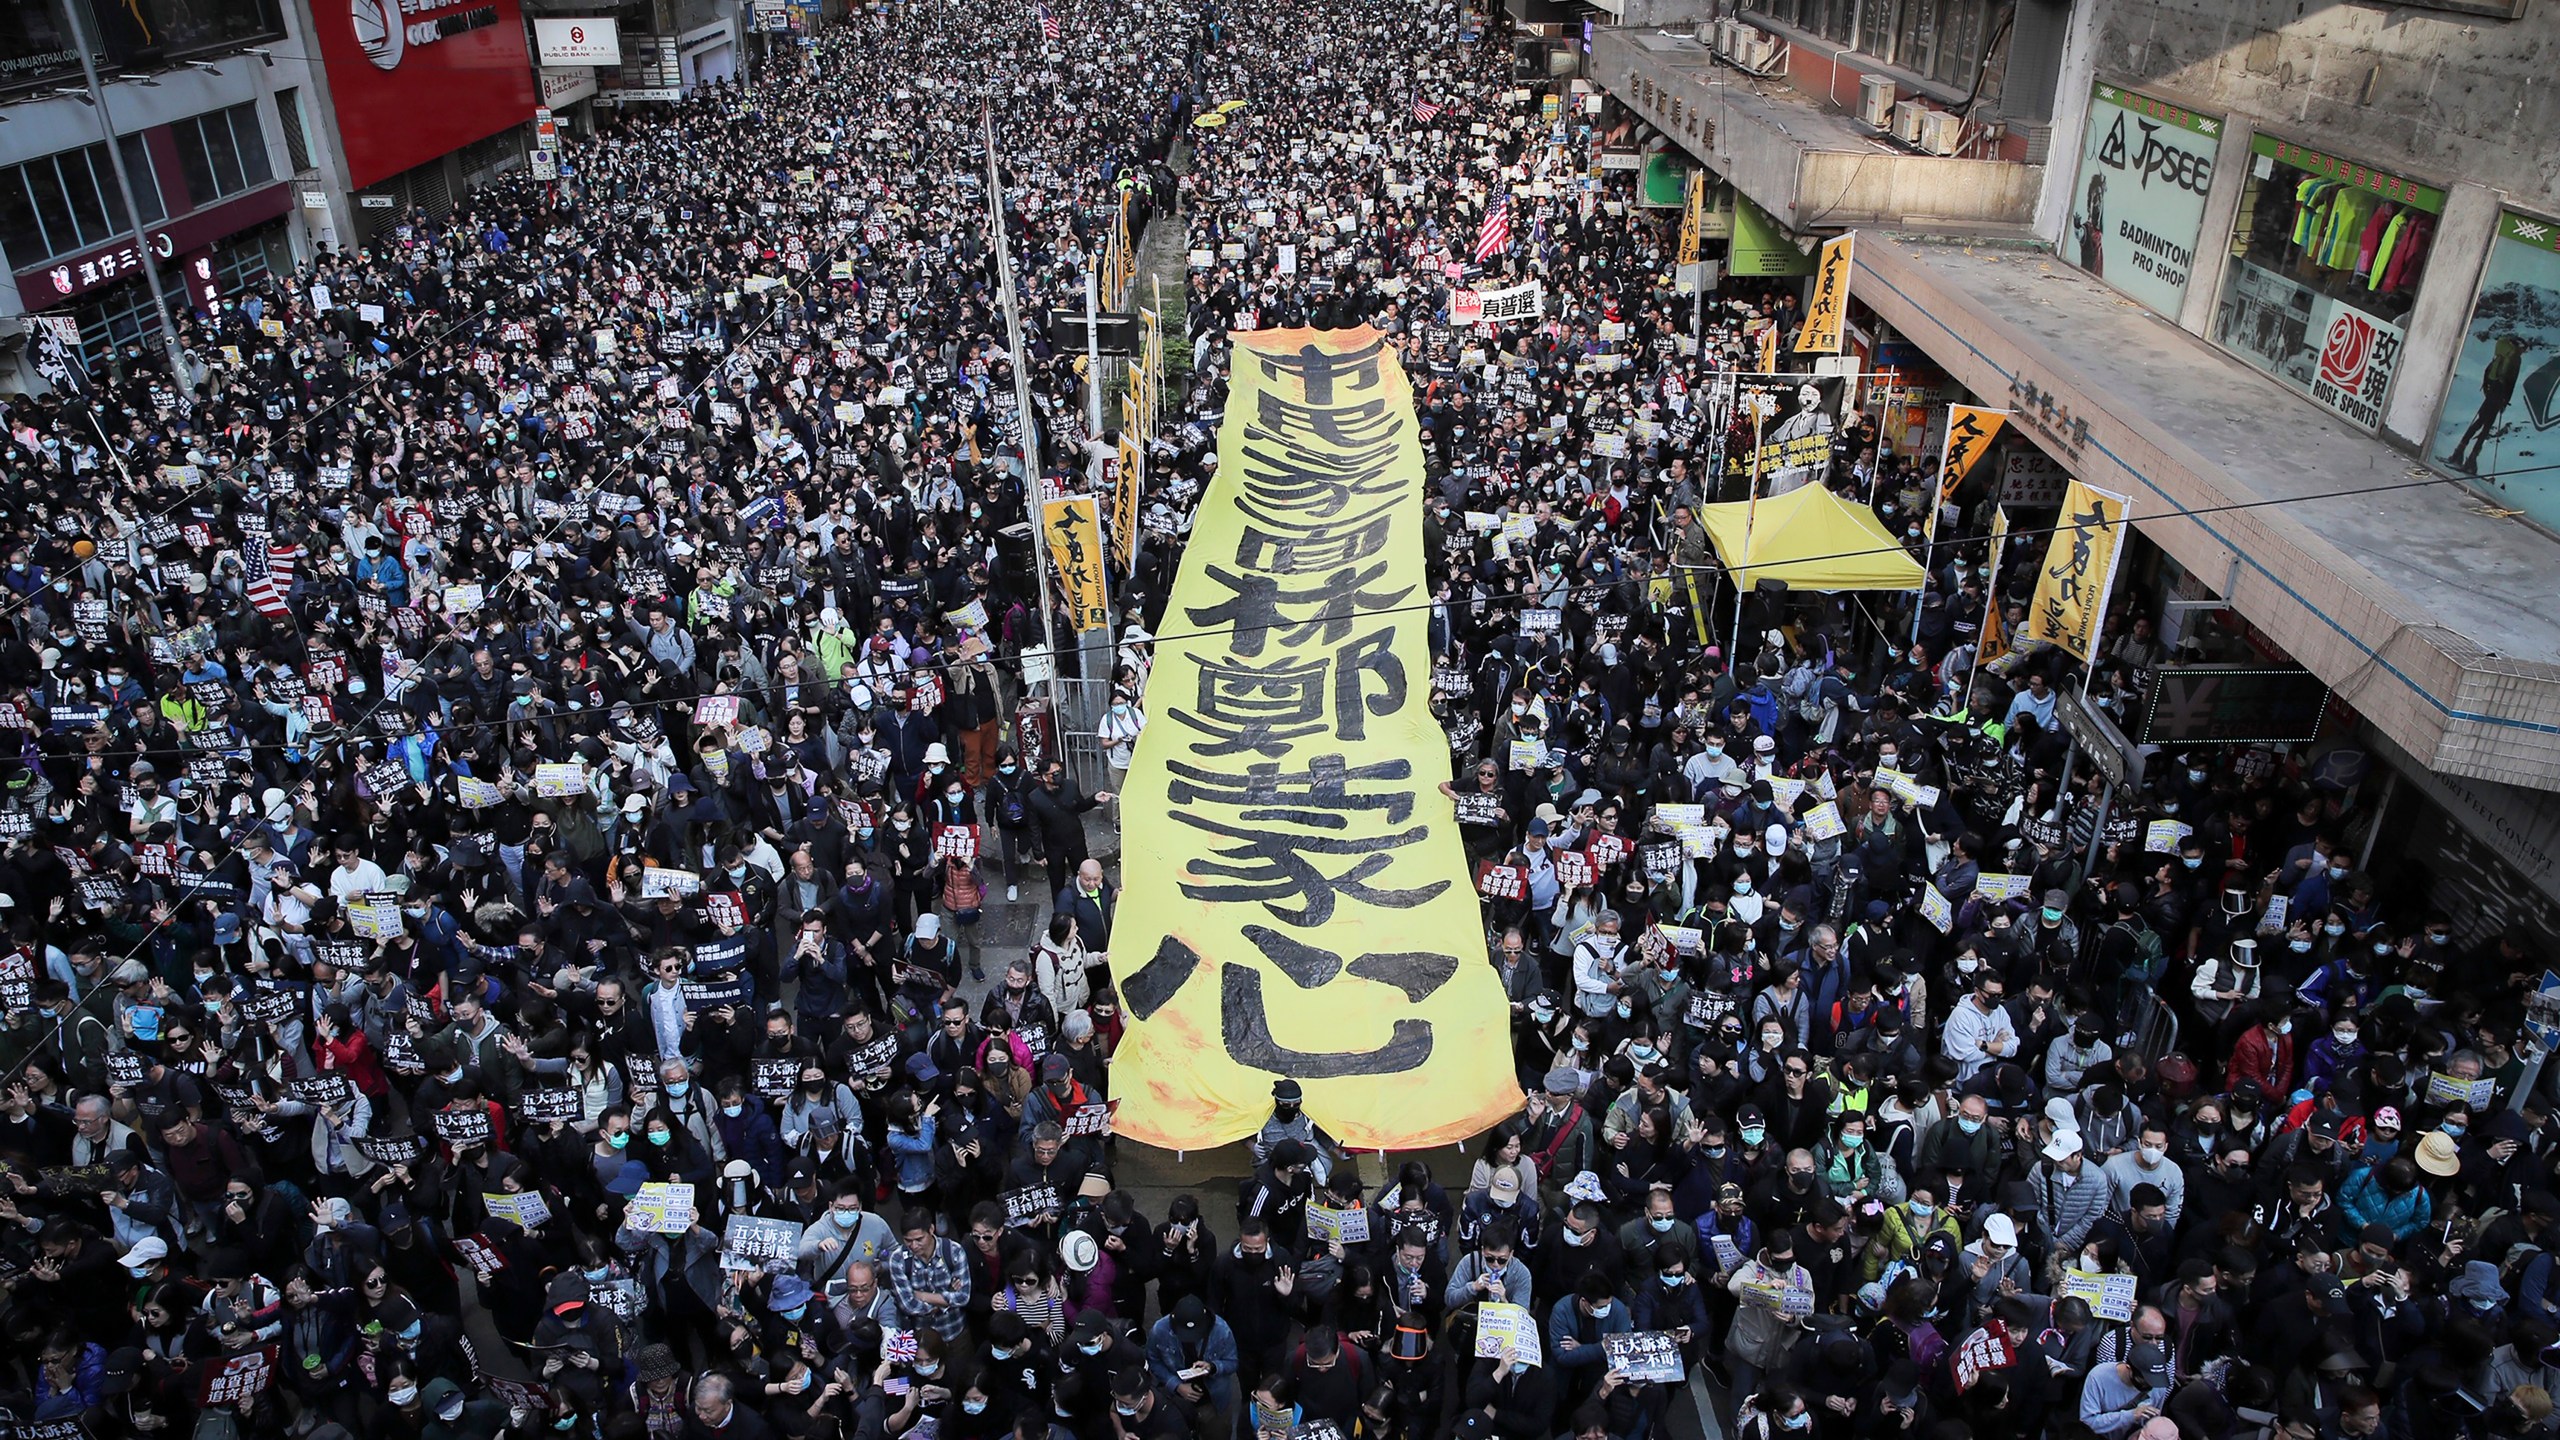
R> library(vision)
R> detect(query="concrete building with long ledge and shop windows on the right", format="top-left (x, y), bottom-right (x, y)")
top-left (1587, 0), bottom-right (2560, 933)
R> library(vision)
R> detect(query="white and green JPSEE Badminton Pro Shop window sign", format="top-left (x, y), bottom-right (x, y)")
top-left (2063, 82), bottom-right (2222, 320)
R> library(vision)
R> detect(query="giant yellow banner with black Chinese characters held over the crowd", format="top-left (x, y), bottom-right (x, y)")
top-left (1111, 328), bottom-right (1521, 1150)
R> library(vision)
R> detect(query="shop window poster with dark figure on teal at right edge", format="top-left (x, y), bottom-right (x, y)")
top-left (2427, 210), bottom-right (2560, 530)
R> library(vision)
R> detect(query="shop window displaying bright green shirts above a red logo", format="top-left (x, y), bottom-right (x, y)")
top-left (2214, 136), bottom-right (2445, 430)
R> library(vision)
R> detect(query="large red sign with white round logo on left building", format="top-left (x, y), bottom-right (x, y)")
top-left (312, 0), bottom-right (540, 190)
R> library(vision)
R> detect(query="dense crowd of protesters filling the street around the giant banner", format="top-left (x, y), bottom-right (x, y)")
top-left (0, 0), bottom-right (2560, 1440)
